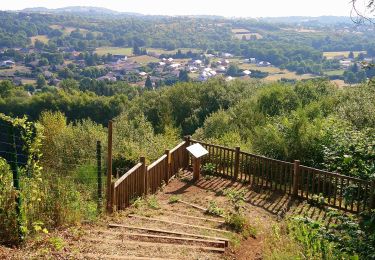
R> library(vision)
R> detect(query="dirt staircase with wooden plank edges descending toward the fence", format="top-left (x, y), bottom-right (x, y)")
top-left (74, 190), bottom-right (234, 260)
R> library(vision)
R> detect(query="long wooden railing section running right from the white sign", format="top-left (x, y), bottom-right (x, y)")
top-left (191, 139), bottom-right (375, 212)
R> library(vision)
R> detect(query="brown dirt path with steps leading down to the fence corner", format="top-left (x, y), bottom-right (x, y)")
top-left (0, 173), bottom-right (322, 260)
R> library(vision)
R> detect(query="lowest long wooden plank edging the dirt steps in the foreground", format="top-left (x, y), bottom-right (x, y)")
top-left (84, 238), bottom-right (225, 253)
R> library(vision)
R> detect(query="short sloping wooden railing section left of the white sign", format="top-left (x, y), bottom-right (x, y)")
top-left (109, 142), bottom-right (188, 211)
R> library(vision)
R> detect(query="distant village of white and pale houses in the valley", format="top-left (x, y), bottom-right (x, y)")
top-left (0, 45), bottom-right (372, 91)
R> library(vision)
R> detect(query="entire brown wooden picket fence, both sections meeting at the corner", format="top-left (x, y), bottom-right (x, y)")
top-left (111, 137), bottom-right (375, 212)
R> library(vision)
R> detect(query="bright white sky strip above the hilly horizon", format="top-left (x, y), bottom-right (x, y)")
top-left (0, 0), bottom-right (358, 17)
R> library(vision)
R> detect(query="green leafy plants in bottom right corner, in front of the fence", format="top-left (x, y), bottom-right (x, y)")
top-left (289, 210), bottom-right (375, 259)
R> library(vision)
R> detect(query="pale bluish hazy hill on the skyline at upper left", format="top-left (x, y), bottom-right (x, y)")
top-left (20, 6), bottom-right (142, 16)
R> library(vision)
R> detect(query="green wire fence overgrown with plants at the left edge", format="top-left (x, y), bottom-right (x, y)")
top-left (0, 118), bottom-right (107, 243)
